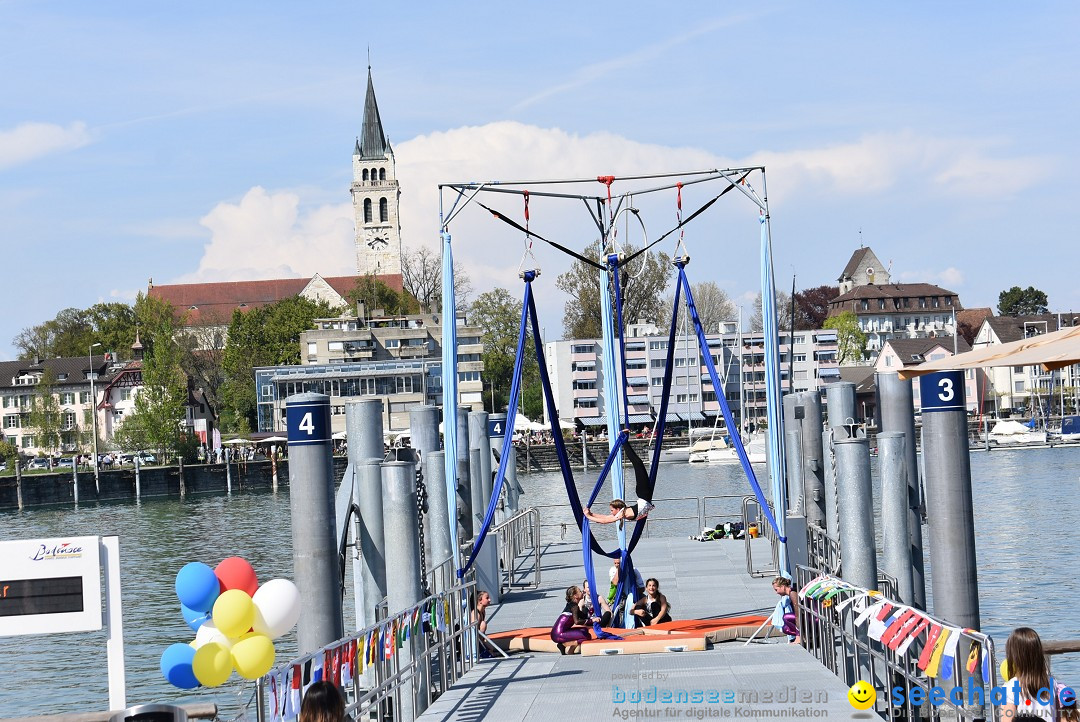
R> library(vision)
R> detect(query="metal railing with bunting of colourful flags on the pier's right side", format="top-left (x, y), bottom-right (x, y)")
top-left (795, 566), bottom-right (1000, 722)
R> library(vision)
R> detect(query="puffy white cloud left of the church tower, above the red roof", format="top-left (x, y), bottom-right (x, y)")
top-left (170, 187), bottom-right (356, 283)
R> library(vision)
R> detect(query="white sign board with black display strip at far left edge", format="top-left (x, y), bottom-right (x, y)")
top-left (0, 536), bottom-right (102, 637)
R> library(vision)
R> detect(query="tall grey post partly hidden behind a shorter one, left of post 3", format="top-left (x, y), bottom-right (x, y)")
top-left (874, 372), bottom-right (927, 609)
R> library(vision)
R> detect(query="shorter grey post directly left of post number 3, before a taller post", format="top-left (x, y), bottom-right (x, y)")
top-left (877, 432), bottom-right (915, 605)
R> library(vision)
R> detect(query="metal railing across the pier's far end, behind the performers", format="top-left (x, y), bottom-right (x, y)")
top-left (535, 494), bottom-right (743, 541)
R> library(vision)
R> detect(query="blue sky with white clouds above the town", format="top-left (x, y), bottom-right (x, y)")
top-left (0, 1), bottom-right (1080, 358)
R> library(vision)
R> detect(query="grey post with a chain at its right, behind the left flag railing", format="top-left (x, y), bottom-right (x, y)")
top-left (382, 461), bottom-right (423, 720)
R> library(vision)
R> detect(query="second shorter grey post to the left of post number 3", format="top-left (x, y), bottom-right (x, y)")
top-left (836, 438), bottom-right (877, 589)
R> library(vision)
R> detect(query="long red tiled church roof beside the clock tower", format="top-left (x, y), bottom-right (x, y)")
top-left (148, 273), bottom-right (403, 326)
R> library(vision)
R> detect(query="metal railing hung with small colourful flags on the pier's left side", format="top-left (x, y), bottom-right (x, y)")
top-left (256, 574), bottom-right (477, 722)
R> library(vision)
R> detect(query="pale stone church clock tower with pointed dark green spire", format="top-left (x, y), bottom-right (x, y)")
top-left (351, 67), bottom-right (402, 275)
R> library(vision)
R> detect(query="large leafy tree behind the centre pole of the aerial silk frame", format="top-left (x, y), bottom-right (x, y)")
top-left (555, 236), bottom-right (671, 339)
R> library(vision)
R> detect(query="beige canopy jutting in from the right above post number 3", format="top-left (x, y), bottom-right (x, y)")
top-left (899, 326), bottom-right (1080, 379)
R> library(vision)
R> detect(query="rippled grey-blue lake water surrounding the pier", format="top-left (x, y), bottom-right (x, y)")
top-left (0, 448), bottom-right (1080, 717)
